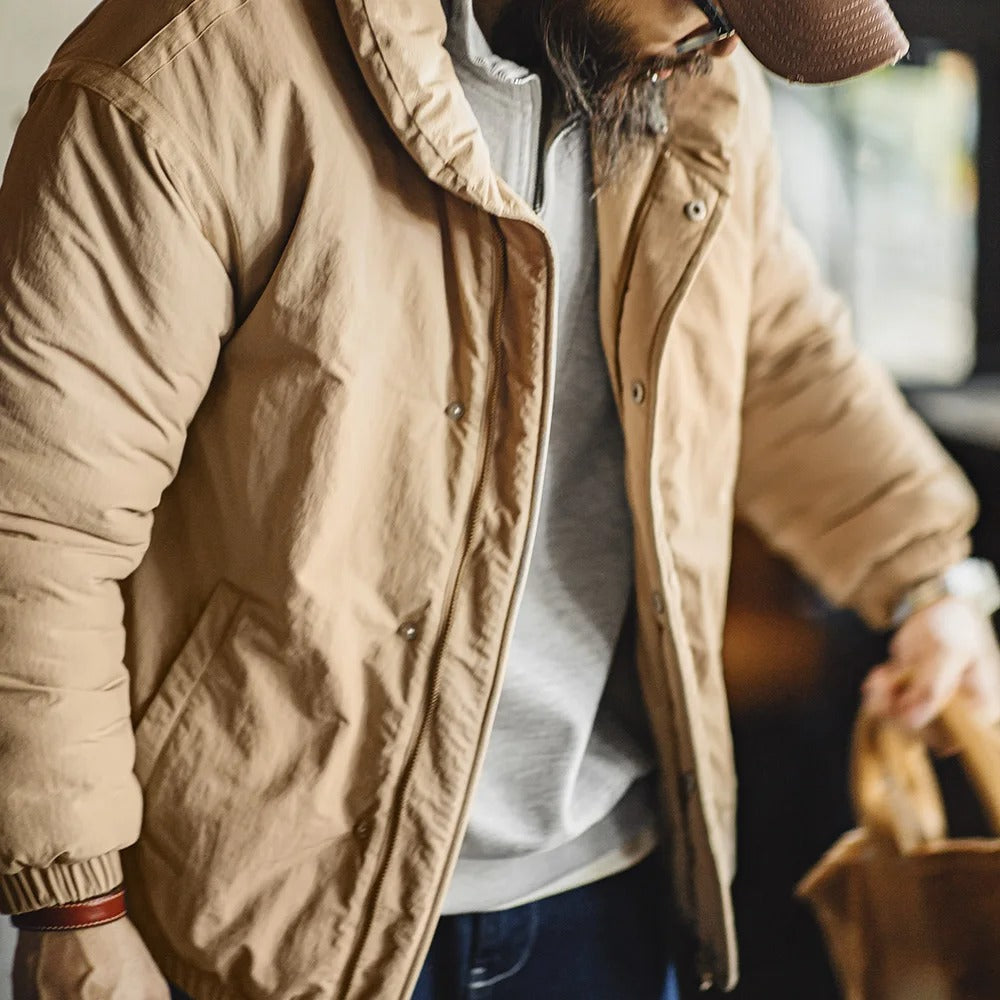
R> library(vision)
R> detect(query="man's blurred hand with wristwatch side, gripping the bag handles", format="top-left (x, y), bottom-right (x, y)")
top-left (864, 597), bottom-right (1000, 749)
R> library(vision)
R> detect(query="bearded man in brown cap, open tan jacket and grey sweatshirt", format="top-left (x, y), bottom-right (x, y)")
top-left (0, 0), bottom-right (1000, 1000)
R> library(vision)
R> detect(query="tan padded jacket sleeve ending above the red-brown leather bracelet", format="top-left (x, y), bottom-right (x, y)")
top-left (0, 81), bottom-right (233, 912)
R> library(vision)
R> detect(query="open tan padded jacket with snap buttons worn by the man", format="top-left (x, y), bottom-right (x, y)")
top-left (0, 0), bottom-right (975, 1000)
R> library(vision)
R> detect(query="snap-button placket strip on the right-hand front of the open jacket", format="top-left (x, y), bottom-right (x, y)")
top-left (608, 148), bottom-right (735, 989)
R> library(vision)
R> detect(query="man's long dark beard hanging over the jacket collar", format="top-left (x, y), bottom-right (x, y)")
top-left (493, 0), bottom-right (712, 186)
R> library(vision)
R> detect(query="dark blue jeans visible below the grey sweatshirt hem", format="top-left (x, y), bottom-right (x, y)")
top-left (171, 853), bottom-right (680, 1000)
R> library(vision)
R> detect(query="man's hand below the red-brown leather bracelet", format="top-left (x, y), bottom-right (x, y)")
top-left (14, 918), bottom-right (170, 1000)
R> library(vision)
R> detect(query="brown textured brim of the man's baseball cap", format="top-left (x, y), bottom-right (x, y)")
top-left (720, 0), bottom-right (910, 83)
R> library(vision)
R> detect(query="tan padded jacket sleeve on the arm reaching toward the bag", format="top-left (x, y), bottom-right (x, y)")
top-left (737, 78), bottom-right (977, 627)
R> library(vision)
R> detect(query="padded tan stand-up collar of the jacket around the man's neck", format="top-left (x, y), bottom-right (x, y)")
top-left (336, 0), bottom-right (743, 210)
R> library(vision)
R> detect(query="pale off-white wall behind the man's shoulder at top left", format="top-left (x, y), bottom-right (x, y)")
top-left (0, 0), bottom-right (100, 988)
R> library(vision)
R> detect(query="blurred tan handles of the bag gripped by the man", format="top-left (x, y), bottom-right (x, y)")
top-left (851, 696), bottom-right (1000, 854)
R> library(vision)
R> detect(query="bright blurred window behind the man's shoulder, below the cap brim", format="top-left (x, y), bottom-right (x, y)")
top-left (773, 51), bottom-right (979, 385)
